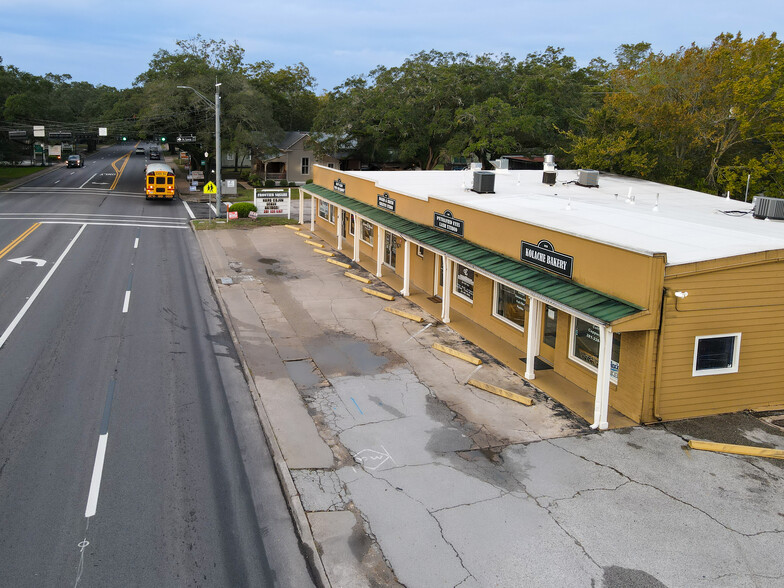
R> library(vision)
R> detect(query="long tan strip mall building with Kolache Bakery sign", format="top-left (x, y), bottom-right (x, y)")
top-left (300, 166), bottom-right (784, 429)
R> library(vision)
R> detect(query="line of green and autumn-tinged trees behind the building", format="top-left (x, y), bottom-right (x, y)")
top-left (0, 33), bottom-right (784, 197)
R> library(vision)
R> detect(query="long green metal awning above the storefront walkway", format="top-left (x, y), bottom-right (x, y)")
top-left (301, 184), bottom-right (644, 324)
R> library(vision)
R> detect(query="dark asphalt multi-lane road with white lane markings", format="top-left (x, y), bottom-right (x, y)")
top-left (0, 144), bottom-right (311, 586)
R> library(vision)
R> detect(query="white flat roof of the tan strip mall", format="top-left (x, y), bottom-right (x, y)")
top-left (340, 170), bottom-right (784, 265)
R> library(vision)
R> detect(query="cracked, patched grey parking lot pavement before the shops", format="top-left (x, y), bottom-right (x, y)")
top-left (199, 227), bottom-right (784, 588)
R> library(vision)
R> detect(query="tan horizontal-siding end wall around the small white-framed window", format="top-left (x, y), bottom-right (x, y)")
top-left (656, 261), bottom-right (784, 420)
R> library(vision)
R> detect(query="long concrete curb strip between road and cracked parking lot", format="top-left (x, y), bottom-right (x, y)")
top-left (190, 223), bottom-right (332, 588)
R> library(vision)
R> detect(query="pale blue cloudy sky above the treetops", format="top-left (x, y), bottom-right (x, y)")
top-left (0, 0), bottom-right (784, 91)
